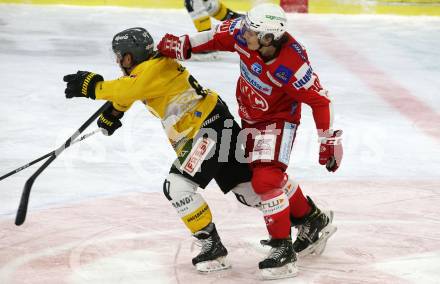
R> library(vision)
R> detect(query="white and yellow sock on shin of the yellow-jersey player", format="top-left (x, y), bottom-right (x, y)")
top-left (163, 173), bottom-right (212, 233)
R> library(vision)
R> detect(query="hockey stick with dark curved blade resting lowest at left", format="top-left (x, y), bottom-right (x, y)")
top-left (15, 102), bottom-right (112, 226)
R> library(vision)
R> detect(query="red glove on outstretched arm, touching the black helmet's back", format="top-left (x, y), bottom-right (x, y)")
top-left (157, 34), bottom-right (191, 61)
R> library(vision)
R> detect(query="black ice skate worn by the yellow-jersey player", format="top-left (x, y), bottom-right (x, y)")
top-left (192, 223), bottom-right (231, 272)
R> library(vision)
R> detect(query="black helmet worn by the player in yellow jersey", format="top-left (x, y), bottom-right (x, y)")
top-left (112, 28), bottom-right (154, 64)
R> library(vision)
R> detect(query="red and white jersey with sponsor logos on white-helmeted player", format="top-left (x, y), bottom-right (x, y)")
top-left (190, 19), bottom-right (332, 131)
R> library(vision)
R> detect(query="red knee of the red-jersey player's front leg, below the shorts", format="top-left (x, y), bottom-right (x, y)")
top-left (252, 166), bottom-right (286, 195)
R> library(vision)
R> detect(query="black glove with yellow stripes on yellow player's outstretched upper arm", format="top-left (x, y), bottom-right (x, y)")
top-left (63, 71), bottom-right (104, 99)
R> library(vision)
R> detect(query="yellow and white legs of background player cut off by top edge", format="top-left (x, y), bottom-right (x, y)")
top-left (185, 0), bottom-right (242, 32)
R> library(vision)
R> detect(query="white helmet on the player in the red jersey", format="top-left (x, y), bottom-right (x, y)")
top-left (243, 3), bottom-right (287, 40)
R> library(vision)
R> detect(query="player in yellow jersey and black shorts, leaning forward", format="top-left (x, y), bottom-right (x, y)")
top-left (64, 28), bottom-right (260, 272)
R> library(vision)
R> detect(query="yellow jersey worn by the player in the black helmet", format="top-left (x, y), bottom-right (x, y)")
top-left (95, 57), bottom-right (218, 156)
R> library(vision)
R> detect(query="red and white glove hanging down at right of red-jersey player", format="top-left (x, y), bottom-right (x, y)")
top-left (319, 130), bottom-right (343, 172)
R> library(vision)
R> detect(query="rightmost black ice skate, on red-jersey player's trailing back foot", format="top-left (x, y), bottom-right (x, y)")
top-left (293, 196), bottom-right (337, 256)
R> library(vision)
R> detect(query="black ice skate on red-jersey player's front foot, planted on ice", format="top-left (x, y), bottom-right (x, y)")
top-left (258, 238), bottom-right (298, 280)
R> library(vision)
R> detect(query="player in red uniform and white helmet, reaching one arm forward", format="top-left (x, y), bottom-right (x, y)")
top-left (158, 1), bottom-right (342, 279)
